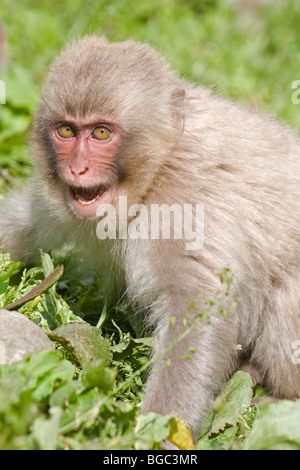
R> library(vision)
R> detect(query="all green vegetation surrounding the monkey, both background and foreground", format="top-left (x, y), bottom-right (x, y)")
top-left (0, 0), bottom-right (300, 449)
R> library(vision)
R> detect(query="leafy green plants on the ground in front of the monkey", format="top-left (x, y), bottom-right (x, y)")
top-left (0, 248), bottom-right (300, 450)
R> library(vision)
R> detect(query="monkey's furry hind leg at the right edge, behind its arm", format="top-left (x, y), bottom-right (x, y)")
top-left (251, 273), bottom-right (300, 399)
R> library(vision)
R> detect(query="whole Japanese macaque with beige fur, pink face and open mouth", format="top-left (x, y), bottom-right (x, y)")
top-left (0, 37), bottom-right (300, 438)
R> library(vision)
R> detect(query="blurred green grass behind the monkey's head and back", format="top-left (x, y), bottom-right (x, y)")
top-left (0, 0), bottom-right (300, 192)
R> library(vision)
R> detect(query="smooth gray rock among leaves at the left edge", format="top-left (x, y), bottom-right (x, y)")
top-left (0, 309), bottom-right (54, 364)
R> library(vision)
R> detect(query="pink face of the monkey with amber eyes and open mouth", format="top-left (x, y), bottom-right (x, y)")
top-left (50, 119), bottom-right (120, 217)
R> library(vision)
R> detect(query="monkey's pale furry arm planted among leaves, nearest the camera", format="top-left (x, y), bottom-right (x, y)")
top-left (127, 241), bottom-right (238, 439)
